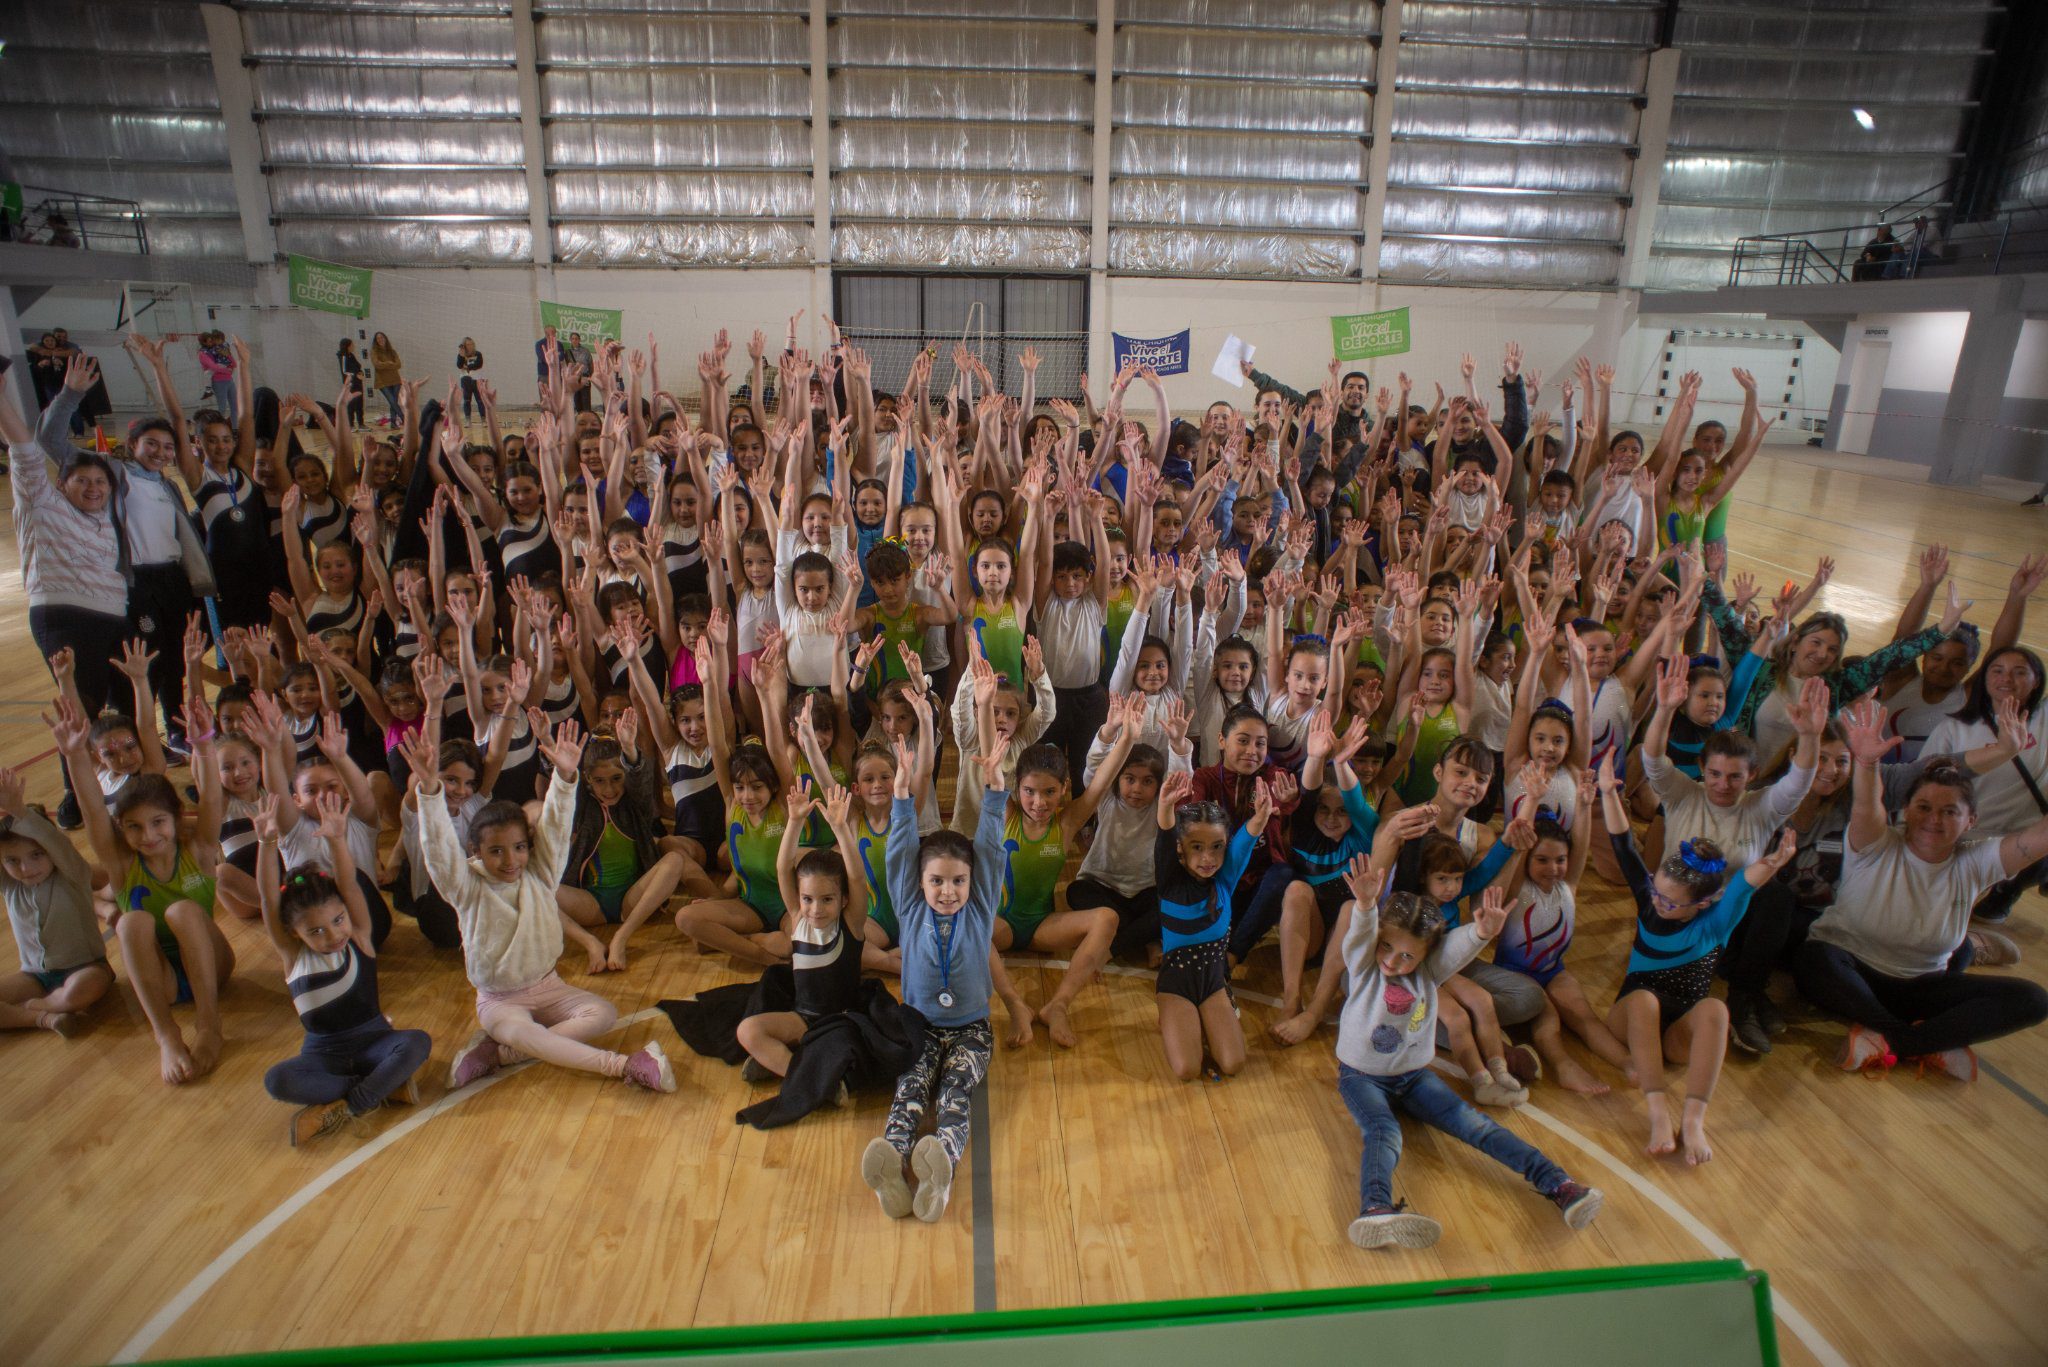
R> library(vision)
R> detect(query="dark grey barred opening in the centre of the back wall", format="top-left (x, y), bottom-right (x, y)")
top-left (831, 271), bottom-right (1087, 400)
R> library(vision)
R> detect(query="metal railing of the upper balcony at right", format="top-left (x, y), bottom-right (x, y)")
top-left (1729, 205), bottom-right (2048, 285)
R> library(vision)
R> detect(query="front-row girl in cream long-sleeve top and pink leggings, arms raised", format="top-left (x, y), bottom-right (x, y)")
top-left (403, 680), bottom-right (676, 1092)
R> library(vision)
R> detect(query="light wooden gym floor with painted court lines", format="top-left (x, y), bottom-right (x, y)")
top-left (0, 449), bottom-right (2048, 1365)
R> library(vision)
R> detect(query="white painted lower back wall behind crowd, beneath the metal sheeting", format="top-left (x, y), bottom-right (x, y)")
top-left (23, 268), bottom-right (1875, 459)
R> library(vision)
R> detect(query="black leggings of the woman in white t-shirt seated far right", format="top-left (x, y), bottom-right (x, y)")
top-left (1794, 941), bottom-right (2048, 1058)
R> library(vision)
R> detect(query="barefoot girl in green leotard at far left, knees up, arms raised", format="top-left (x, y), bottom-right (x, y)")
top-left (43, 697), bottom-right (236, 1084)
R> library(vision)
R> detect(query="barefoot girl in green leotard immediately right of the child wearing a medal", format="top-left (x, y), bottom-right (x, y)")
top-left (989, 693), bottom-right (1146, 1047)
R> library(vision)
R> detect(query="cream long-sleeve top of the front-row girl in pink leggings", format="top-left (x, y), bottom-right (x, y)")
top-left (418, 773), bottom-right (575, 992)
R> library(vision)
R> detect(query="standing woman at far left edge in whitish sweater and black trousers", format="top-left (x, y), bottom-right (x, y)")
top-left (0, 353), bottom-right (127, 830)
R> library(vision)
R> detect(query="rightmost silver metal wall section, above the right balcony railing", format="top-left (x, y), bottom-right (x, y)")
top-left (1651, 0), bottom-right (1999, 289)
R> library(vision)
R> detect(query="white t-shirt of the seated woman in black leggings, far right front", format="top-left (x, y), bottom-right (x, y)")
top-left (1812, 826), bottom-right (2005, 978)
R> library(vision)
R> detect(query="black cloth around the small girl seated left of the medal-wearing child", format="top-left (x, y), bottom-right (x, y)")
top-left (655, 965), bottom-right (926, 1129)
